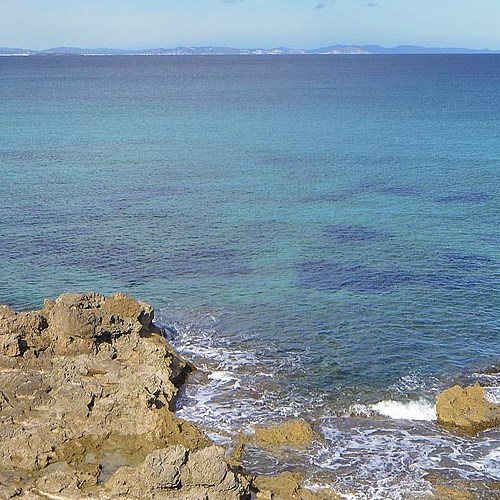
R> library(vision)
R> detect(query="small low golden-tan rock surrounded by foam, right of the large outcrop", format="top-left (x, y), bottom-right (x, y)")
top-left (255, 419), bottom-right (316, 448)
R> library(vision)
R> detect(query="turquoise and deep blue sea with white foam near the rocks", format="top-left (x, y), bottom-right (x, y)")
top-left (0, 55), bottom-right (500, 500)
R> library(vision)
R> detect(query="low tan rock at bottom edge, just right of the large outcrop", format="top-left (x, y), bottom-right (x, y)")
top-left (252, 472), bottom-right (340, 500)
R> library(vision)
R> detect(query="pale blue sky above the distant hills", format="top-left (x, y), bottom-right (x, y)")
top-left (0, 0), bottom-right (500, 49)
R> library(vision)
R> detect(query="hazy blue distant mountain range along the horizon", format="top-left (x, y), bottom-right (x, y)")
top-left (0, 45), bottom-right (500, 56)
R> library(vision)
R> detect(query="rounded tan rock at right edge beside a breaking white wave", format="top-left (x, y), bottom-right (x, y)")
top-left (436, 384), bottom-right (500, 432)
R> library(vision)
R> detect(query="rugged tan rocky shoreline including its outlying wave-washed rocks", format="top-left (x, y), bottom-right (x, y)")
top-left (0, 293), bottom-right (500, 500)
